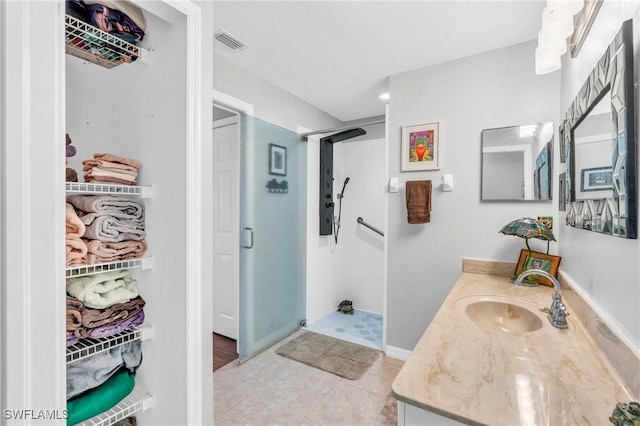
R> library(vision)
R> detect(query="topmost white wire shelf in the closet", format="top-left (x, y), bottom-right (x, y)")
top-left (64, 15), bottom-right (141, 68)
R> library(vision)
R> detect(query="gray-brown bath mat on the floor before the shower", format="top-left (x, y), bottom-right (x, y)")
top-left (276, 332), bottom-right (380, 380)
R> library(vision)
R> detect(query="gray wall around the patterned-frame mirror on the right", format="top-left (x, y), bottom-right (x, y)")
top-left (557, 1), bottom-right (640, 352)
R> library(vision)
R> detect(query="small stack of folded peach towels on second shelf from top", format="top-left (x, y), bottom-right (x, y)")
top-left (82, 153), bottom-right (140, 185)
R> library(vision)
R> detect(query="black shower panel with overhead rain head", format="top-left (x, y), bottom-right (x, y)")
top-left (318, 128), bottom-right (367, 235)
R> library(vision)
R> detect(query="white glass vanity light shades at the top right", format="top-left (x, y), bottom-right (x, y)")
top-left (535, 0), bottom-right (584, 74)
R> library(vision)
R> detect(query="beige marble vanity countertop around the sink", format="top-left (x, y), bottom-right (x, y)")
top-left (392, 272), bottom-right (633, 426)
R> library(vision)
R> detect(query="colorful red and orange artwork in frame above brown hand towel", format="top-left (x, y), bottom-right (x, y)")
top-left (402, 123), bottom-right (440, 172)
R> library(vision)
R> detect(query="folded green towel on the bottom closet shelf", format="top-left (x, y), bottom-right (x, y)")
top-left (67, 370), bottom-right (136, 425)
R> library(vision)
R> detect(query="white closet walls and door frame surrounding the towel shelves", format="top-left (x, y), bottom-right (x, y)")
top-left (0, 1), bottom-right (213, 426)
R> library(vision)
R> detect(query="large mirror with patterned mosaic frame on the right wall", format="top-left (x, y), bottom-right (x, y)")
top-left (560, 20), bottom-right (637, 238)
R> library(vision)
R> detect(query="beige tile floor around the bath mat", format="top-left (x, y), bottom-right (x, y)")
top-left (213, 331), bottom-right (403, 426)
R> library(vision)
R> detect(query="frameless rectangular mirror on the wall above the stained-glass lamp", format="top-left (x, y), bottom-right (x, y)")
top-left (480, 122), bottom-right (553, 201)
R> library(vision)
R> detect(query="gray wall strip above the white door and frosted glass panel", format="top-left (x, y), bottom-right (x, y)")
top-left (213, 53), bottom-right (342, 133)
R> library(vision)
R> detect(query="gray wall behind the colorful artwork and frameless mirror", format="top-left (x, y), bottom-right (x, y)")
top-left (387, 42), bottom-right (560, 349)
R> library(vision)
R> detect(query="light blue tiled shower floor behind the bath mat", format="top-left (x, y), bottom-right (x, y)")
top-left (306, 309), bottom-right (382, 350)
